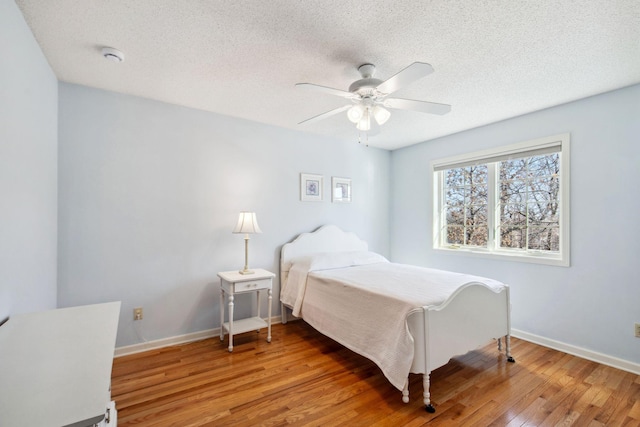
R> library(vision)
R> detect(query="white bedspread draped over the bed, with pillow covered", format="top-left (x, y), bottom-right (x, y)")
top-left (281, 253), bottom-right (505, 390)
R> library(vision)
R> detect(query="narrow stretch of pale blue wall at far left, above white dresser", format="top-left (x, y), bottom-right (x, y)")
top-left (0, 0), bottom-right (58, 320)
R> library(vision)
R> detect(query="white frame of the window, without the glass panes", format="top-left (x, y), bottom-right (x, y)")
top-left (431, 133), bottom-right (571, 267)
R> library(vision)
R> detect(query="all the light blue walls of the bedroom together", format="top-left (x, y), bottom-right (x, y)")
top-left (0, 0), bottom-right (640, 363)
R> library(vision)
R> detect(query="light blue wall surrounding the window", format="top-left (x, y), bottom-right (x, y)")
top-left (390, 85), bottom-right (640, 363)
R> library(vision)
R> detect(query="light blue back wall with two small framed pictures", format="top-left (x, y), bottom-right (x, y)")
top-left (58, 83), bottom-right (390, 346)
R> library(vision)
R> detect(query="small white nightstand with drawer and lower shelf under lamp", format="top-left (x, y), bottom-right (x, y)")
top-left (218, 268), bottom-right (275, 352)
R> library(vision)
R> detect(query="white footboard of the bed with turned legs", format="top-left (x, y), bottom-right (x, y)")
top-left (402, 284), bottom-right (514, 412)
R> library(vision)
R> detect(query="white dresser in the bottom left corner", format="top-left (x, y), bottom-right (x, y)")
top-left (0, 302), bottom-right (120, 427)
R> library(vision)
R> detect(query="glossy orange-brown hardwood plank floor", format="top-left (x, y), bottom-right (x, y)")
top-left (112, 321), bottom-right (640, 427)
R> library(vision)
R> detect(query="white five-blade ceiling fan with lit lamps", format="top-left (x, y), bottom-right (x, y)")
top-left (296, 62), bottom-right (451, 132)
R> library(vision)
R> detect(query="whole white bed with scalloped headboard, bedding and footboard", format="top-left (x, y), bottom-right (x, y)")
top-left (280, 225), bottom-right (514, 412)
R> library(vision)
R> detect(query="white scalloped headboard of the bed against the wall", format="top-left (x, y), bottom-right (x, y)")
top-left (280, 225), bottom-right (369, 284)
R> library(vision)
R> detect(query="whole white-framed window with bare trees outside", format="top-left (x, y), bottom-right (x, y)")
top-left (432, 134), bottom-right (569, 266)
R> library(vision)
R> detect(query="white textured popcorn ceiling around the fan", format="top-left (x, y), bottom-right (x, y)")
top-left (16, 0), bottom-right (640, 149)
